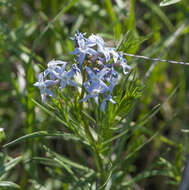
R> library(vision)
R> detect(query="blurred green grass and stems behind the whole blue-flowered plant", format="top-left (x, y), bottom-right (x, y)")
top-left (0, 0), bottom-right (189, 190)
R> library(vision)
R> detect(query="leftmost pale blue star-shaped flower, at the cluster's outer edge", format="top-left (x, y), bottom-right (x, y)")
top-left (34, 73), bottom-right (58, 102)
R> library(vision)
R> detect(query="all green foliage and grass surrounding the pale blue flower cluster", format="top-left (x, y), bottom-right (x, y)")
top-left (0, 0), bottom-right (189, 190)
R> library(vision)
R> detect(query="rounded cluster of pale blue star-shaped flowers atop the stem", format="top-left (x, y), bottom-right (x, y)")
top-left (34, 32), bottom-right (131, 111)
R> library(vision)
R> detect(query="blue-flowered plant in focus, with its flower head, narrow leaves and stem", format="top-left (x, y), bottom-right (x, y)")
top-left (31, 32), bottom-right (145, 188)
